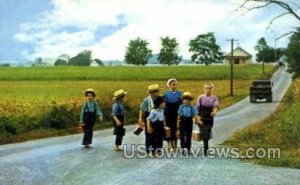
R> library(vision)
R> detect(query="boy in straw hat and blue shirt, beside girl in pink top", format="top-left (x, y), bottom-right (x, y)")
top-left (177, 92), bottom-right (200, 154)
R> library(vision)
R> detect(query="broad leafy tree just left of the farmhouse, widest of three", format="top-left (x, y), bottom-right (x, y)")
top-left (189, 32), bottom-right (223, 65)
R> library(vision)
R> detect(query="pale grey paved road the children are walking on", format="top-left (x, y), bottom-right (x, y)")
top-left (0, 66), bottom-right (300, 185)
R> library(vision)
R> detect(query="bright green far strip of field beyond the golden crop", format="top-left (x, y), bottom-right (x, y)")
top-left (0, 65), bottom-right (273, 81)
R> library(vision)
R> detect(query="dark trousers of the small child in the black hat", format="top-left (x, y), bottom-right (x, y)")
top-left (151, 121), bottom-right (165, 152)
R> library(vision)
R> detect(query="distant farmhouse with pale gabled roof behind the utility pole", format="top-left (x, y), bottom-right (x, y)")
top-left (225, 46), bottom-right (252, 64)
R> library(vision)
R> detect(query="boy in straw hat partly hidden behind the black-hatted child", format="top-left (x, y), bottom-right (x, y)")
top-left (139, 84), bottom-right (162, 154)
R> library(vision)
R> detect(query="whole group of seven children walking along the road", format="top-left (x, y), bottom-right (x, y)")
top-left (80, 79), bottom-right (219, 156)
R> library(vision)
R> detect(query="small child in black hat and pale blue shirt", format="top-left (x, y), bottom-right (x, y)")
top-left (147, 96), bottom-right (165, 156)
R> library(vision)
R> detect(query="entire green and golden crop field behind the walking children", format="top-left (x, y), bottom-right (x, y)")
top-left (0, 65), bottom-right (275, 144)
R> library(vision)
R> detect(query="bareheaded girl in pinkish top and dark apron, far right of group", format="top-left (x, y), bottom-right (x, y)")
top-left (197, 83), bottom-right (219, 155)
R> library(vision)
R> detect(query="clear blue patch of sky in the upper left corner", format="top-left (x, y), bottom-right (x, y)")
top-left (0, 0), bottom-right (53, 60)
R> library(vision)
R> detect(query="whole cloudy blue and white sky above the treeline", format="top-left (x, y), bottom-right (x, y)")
top-left (0, 0), bottom-right (300, 60)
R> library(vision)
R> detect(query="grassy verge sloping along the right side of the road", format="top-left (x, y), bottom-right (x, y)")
top-left (224, 78), bottom-right (300, 169)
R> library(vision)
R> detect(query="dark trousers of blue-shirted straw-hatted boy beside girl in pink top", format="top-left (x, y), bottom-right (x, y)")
top-left (179, 117), bottom-right (193, 151)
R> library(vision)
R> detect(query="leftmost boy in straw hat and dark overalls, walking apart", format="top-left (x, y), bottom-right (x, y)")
top-left (80, 89), bottom-right (103, 148)
